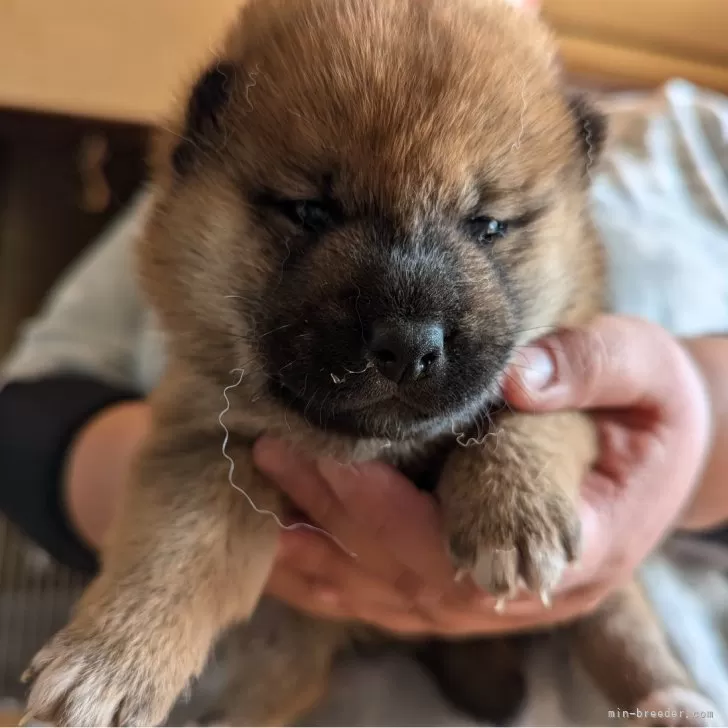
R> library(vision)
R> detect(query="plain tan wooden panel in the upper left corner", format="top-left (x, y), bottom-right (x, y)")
top-left (0, 0), bottom-right (240, 124)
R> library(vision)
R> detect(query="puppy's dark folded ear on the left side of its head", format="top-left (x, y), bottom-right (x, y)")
top-left (172, 63), bottom-right (235, 175)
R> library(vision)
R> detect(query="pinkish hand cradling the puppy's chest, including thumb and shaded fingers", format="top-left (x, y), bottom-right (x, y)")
top-left (255, 317), bottom-right (709, 635)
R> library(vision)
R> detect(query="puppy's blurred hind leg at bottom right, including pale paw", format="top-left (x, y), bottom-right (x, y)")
top-left (572, 583), bottom-right (723, 726)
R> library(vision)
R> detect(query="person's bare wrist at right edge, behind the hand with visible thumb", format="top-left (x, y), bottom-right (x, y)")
top-left (680, 336), bottom-right (728, 530)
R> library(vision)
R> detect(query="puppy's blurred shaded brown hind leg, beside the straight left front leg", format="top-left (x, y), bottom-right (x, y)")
top-left (205, 599), bottom-right (349, 726)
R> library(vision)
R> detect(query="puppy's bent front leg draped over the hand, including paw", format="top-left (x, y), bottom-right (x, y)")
top-left (437, 412), bottom-right (596, 603)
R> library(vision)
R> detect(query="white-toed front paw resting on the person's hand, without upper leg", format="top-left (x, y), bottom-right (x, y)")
top-left (445, 485), bottom-right (579, 608)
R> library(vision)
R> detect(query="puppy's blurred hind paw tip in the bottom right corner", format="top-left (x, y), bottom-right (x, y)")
top-left (630, 687), bottom-right (725, 727)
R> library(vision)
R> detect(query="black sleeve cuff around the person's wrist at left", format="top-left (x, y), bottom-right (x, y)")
top-left (0, 374), bottom-right (139, 571)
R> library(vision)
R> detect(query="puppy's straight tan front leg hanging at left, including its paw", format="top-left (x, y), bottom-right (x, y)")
top-left (22, 433), bottom-right (278, 726)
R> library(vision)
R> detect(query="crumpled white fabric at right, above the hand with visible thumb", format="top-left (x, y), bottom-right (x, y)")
top-left (593, 81), bottom-right (728, 336)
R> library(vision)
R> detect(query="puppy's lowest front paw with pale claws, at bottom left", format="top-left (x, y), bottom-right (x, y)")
top-left (23, 625), bottom-right (183, 726)
